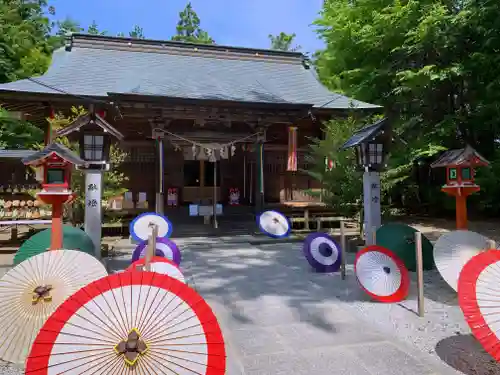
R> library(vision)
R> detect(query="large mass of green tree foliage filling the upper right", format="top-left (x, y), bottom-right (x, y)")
top-left (315, 0), bottom-right (500, 213)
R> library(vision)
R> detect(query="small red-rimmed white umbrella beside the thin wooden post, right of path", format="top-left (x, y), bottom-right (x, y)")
top-left (354, 245), bottom-right (410, 302)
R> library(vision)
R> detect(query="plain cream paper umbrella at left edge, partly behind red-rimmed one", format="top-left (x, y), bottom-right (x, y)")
top-left (0, 250), bottom-right (107, 363)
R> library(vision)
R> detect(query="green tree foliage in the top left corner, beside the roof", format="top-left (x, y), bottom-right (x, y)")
top-left (0, 0), bottom-right (52, 83)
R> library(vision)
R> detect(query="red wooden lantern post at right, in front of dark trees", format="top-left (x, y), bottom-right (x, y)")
top-left (431, 146), bottom-right (489, 229)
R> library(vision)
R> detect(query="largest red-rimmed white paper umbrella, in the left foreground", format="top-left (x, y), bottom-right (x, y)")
top-left (26, 272), bottom-right (226, 375)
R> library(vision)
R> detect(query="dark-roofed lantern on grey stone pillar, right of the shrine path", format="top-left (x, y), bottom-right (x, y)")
top-left (342, 118), bottom-right (392, 246)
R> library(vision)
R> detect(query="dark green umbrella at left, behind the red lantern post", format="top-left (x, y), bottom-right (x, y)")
top-left (14, 225), bottom-right (94, 265)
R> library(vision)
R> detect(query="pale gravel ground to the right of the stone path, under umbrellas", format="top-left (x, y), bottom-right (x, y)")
top-left (261, 244), bottom-right (500, 375)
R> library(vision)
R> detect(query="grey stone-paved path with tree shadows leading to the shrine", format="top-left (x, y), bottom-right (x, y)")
top-left (109, 238), bottom-right (458, 375)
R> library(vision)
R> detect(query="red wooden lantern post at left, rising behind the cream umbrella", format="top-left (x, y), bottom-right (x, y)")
top-left (22, 143), bottom-right (84, 250)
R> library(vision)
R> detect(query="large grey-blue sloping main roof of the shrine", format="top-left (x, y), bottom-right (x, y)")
top-left (0, 34), bottom-right (379, 109)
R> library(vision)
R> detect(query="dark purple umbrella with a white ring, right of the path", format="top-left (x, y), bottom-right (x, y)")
top-left (303, 233), bottom-right (342, 272)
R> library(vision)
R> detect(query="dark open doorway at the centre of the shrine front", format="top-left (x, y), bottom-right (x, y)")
top-left (181, 160), bottom-right (221, 204)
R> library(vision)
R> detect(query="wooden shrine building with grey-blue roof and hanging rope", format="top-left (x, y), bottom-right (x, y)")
top-left (0, 34), bottom-right (380, 219)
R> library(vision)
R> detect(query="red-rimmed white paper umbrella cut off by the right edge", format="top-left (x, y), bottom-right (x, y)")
top-left (458, 249), bottom-right (500, 362)
